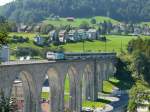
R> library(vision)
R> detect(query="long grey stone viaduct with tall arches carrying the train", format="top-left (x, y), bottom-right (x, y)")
top-left (0, 53), bottom-right (116, 112)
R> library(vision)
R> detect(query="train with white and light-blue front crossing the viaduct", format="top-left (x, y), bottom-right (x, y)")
top-left (46, 52), bottom-right (116, 60)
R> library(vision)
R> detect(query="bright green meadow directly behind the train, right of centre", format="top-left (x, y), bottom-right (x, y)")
top-left (62, 35), bottom-right (136, 52)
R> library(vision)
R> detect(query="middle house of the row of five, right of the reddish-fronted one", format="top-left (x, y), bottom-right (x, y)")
top-left (67, 30), bottom-right (79, 41)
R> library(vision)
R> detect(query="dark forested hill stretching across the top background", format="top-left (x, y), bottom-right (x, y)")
top-left (0, 0), bottom-right (150, 23)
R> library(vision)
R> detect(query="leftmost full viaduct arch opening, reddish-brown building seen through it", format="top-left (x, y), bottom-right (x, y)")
top-left (11, 71), bottom-right (36, 112)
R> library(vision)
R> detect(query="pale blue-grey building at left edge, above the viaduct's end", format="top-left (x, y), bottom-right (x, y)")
top-left (0, 46), bottom-right (10, 61)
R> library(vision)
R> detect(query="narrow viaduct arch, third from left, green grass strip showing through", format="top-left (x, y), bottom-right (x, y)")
top-left (64, 66), bottom-right (78, 112)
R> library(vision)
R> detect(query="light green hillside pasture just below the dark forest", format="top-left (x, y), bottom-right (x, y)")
top-left (43, 16), bottom-right (119, 27)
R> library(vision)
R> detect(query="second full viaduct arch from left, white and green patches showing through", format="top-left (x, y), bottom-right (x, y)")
top-left (41, 68), bottom-right (60, 112)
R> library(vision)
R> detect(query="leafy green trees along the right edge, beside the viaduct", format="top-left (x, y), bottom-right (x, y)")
top-left (128, 37), bottom-right (150, 112)
